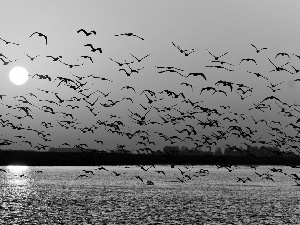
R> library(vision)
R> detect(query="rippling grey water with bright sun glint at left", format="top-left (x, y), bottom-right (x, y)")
top-left (0, 166), bottom-right (300, 224)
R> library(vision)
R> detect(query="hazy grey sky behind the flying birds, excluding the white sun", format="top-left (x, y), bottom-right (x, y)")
top-left (0, 0), bottom-right (300, 153)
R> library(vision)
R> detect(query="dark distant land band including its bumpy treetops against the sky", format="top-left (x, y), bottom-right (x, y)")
top-left (0, 146), bottom-right (300, 166)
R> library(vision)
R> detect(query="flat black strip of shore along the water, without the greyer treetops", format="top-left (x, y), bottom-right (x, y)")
top-left (0, 151), bottom-right (300, 166)
